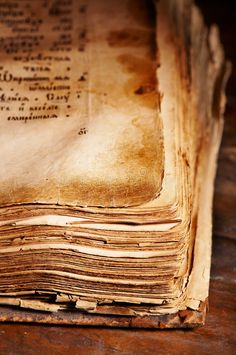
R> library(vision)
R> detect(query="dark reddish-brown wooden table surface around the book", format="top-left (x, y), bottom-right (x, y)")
top-left (0, 0), bottom-right (236, 355)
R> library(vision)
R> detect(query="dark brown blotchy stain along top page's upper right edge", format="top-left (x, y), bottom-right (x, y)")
top-left (107, 0), bottom-right (160, 110)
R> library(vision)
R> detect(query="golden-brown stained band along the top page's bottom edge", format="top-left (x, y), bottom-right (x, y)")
top-left (0, 177), bottom-right (159, 207)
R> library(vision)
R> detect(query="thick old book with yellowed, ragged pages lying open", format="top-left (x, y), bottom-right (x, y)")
top-left (0, 0), bottom-right (229, 327)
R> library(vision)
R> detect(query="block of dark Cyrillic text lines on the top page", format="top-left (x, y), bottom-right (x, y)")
top-left (0, 0), bottom-right (88, 128)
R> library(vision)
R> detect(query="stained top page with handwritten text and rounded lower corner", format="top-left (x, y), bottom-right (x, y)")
top-left (0, 0), bottom-right (164, 207)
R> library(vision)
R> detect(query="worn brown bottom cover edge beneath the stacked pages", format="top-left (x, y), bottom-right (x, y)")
top-left (0, 302), bottom-right (207, 329)
